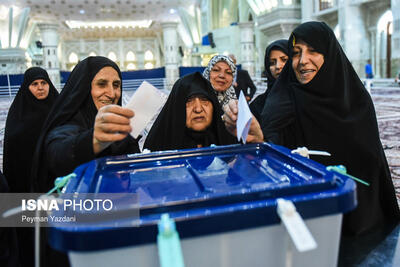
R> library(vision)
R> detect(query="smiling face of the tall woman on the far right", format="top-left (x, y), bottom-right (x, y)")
top-left (292, 40), bottom-right (324, 84)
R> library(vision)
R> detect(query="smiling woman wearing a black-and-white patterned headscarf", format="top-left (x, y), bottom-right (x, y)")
top-left (203, 55), bottom-right (237, 107)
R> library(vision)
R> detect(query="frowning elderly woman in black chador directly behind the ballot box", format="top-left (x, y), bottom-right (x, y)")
top-left (144, 72), bottom-right (237, 151)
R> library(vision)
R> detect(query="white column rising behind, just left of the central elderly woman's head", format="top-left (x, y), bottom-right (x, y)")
top-left (161, 22), bottom-right (179, 89)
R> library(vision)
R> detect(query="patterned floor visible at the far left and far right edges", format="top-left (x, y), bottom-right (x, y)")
top-left (0, 87), bottom-right (400, 202)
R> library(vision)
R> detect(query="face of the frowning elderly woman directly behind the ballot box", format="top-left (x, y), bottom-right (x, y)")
top-left (186, 95), bottom-right (214, 131)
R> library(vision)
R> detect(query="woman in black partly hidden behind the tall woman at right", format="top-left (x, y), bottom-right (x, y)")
top-left (250, 39), bottom-right (288, 121)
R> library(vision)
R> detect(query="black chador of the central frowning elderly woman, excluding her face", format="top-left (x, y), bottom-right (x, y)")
top-left (144, 72), bottom-right (236, 151)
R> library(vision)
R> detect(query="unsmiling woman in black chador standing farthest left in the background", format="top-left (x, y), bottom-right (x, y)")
top-left (3, 67), bottom-right (58, 193)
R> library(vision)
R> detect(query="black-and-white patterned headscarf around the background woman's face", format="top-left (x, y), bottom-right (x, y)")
top-left (203, 55), bottom-right (237, 106)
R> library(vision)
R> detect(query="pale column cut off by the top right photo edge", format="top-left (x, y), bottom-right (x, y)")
top-left (391, 0), bottom-right (400, 75)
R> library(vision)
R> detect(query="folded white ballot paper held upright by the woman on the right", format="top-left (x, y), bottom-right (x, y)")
top-left (236, 91), bottom-right (253, 144)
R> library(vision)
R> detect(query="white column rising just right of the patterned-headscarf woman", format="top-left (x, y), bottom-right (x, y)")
top-left (239, 22), bottom-right (255, 76)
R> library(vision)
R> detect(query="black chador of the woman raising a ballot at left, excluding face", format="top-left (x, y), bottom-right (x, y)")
top-left (32, 56), bottom-right (140, 192)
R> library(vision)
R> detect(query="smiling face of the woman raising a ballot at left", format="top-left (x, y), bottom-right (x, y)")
top-left (91, 66), bottom-right (121, 110)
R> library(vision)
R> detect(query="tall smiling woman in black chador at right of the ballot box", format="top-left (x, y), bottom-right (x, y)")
top-left (262, 22), bottom-right (400, 235)
